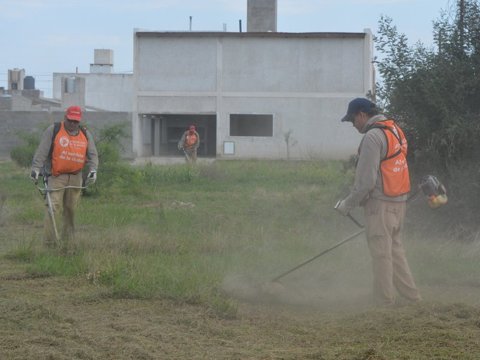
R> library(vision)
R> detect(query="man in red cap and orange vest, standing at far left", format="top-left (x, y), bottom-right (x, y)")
top-left (30, 106), bottom-right (98, 246)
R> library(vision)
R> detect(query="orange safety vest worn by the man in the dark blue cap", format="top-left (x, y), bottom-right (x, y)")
top-left (370, 120), bottom-right (410, 196)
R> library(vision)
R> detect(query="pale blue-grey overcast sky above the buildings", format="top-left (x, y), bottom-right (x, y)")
top-left (0, 0), bottom-right (456, 97)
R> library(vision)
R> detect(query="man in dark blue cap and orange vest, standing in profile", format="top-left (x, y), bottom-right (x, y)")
top-left (336, 98), bottom-right (421, 306)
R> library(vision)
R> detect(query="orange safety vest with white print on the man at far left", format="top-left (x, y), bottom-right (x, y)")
top-left (52, 122), bottom-right (88, 176)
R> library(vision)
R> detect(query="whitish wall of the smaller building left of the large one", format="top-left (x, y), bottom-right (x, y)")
top-left (53, 73), bottom-right (133, 112)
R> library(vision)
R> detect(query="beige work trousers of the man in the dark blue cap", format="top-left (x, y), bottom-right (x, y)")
top-left (365, 199), bottom-right (421, 306)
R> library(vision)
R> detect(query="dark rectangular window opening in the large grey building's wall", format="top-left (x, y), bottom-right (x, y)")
top-left (230, 114), bottom-right (273, 136)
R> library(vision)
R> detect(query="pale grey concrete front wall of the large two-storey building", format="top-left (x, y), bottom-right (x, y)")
top-left (132, 31), bottom-right (373, 159)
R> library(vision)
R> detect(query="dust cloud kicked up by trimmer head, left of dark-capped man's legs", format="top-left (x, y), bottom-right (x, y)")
top-left (222, 248), bottom-right (372, 312)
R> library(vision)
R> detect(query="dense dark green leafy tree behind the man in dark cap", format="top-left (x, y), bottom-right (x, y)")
top-left (375, 0), bottom-right (480, 239)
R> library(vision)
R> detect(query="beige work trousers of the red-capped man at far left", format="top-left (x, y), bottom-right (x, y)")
top-left (44, 172), bottom-right (82, 246)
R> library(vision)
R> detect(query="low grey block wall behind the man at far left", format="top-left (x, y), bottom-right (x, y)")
top-left (0, 111), bottom-right (133, 158)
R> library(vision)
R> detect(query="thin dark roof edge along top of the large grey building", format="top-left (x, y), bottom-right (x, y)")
top-left (134, 29), bottom-right (367, 38)
